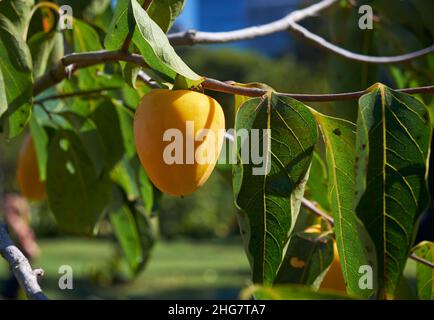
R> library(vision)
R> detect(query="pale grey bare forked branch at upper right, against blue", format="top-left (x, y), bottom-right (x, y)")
top-left (168, 0), bottom-right (434, 64)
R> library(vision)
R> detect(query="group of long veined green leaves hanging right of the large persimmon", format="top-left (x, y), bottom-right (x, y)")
top-left (234, 84), bottom-right (432, 299)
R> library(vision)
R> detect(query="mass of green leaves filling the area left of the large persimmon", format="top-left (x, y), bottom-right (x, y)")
top-left (0, 0), bottom-right (197, 274)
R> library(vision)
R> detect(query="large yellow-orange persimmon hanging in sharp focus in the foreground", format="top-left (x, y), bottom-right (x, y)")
top-left (134, 89), bottom-right (225, 196)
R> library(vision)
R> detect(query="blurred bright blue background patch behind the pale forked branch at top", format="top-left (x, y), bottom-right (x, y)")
top-left (176, 0), bottom-right (301, 56)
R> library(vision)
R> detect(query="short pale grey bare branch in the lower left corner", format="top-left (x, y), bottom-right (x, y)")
top-left (0, 222), bottom-right (48, 300)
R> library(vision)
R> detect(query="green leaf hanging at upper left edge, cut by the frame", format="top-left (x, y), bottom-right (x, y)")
top-left (0, 14), bottom-right (33, 138)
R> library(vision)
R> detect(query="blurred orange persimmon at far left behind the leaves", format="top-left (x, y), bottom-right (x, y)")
top-left (17, 135), bottom-right (47, 200)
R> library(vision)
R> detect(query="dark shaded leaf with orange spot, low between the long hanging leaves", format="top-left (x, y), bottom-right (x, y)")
top-left (275, 232), bottom-right (334, 289)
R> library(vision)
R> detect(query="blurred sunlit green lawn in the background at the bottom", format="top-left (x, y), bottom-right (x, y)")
top-left (0, 239), bottom-right (249, 299)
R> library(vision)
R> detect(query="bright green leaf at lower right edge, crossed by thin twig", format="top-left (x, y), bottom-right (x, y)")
top-left (413, 241), bottom-right (434, 300)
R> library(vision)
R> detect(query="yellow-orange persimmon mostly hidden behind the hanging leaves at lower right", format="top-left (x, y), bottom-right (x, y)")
top-left (305, 225), bottom-right (346, 293)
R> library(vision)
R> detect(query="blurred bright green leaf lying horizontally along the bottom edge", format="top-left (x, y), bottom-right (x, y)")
top-left (241, 285), bottom-right (354, 300)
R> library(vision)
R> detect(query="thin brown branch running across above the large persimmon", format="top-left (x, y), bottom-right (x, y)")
top-left (33, 50), bottom-right (434, 102)
